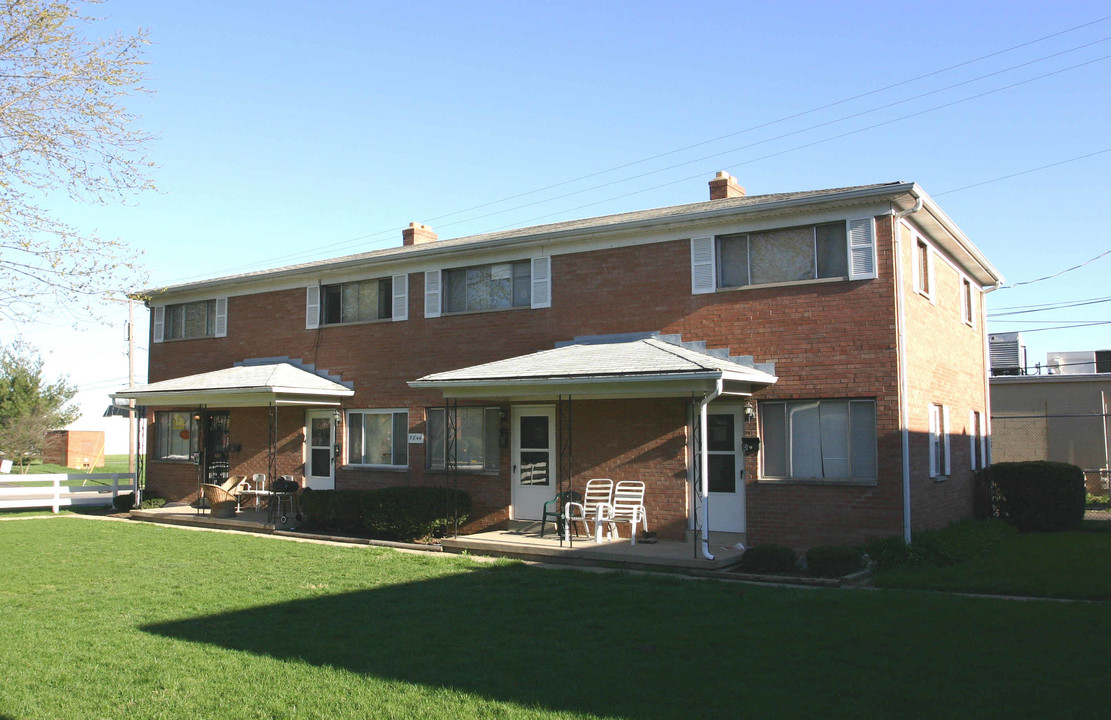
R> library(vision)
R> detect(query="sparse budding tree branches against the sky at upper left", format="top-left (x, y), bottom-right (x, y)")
top-left (0, 0), bottom-right (153, 321)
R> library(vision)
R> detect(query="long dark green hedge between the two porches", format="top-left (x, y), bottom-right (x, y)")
top-left (301, 487), bottom-right (471, 541)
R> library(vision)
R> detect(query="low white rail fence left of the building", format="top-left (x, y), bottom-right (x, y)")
top-left (0, 472), bottom-right (136, 512)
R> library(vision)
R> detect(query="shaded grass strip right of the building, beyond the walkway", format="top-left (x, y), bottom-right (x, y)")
top-left (875, 523), bottom-right (1111, 600)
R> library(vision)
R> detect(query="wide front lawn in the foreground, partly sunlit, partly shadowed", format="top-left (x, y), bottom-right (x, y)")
top-left (0, 517), bottom-right (1111, 720)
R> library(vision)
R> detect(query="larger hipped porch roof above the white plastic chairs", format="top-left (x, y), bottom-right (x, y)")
top-left (409, 337), bottom-right (778, 400)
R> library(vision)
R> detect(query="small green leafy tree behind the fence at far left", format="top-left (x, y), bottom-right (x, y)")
top-left (0, 341), bottom-right (81, 472)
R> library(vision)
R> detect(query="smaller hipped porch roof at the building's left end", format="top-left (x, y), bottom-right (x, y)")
top-left (111, 362), bottom-right (354, 408)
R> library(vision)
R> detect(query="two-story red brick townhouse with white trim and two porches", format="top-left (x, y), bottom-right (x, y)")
top-left (116, 173), bottom-right (1002, 548)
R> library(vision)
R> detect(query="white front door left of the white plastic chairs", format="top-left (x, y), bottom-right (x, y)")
top-left (511, 406), bottom-right (558, 520)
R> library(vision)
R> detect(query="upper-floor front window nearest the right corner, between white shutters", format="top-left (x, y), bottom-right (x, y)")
top-left (717, 222), bottom-right (849, 288)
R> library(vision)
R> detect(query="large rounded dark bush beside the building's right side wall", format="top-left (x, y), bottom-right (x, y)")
top-left (985, 460), bottom-right (1085, 532)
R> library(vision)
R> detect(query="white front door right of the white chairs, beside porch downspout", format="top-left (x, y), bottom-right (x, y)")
top-left (705, 407), bottom-right (744, 532)
